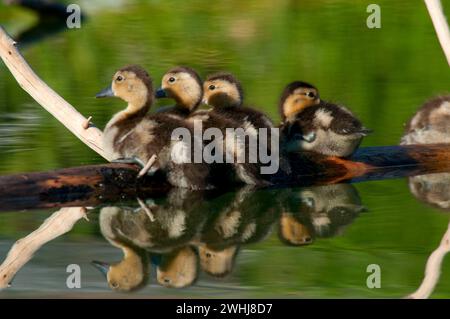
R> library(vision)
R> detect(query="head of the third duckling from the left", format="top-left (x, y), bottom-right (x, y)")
top-left (203, 73), bottom-right (244, 108)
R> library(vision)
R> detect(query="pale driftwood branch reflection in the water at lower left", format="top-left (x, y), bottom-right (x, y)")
top-left (0, 207), bottom-right (86, 289)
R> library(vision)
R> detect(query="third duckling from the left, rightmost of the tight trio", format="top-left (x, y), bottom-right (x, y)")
top-left (203, 73), bottom-right (273, 185)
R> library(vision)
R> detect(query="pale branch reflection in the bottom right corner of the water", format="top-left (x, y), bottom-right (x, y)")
top-left (407, 224), bottom-right (450, 299)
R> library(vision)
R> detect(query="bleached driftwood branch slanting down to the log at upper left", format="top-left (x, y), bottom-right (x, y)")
top-left (0, 26), bottom-right (111, 160)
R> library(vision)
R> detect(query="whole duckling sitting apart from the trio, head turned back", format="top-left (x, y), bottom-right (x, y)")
top-left (279, 81), bottom-right (371, 157)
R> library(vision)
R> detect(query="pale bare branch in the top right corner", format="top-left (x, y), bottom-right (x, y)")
top-left (425, 0), bottom-right (450, 65)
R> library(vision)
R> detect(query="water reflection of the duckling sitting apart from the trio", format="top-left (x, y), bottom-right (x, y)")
top-left (279, 184), bottom-right (366, 246)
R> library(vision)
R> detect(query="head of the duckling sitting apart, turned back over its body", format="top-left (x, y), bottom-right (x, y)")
top-left (279, 81), bottom-right (320, 121)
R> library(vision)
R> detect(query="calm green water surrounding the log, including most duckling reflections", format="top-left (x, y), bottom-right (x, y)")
top-left (0, 0), bottom-right (450, 298)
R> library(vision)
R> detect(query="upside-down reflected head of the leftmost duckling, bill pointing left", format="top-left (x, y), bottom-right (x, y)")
top-left (92, 251), bottom-right (149, 292)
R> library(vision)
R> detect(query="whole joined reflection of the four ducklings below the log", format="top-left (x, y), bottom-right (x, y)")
top-left (93, 184), bottom-right (364, 291)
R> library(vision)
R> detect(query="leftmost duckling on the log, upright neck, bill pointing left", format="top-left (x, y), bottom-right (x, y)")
top-left (97, 65), bottom-right (213, 189)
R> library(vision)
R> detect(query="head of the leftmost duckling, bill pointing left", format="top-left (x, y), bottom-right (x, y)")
top-left (95, 65), bottom-right (154, 110)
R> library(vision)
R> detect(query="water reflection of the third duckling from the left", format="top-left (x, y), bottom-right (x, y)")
top-left (197, 186), bottom-right (279, 277)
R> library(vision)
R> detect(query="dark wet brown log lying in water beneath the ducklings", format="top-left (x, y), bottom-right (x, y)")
top-left (0, 144), bottom-right (450, 211)
